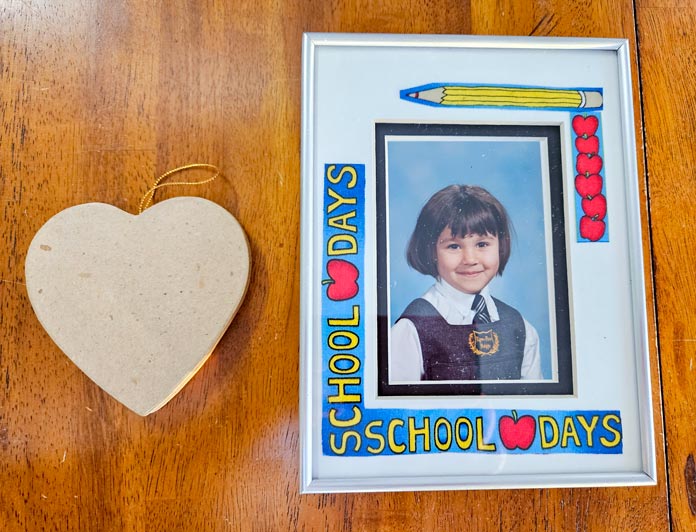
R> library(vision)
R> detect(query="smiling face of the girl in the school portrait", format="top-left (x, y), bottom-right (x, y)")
top-left (435, 226), bottom-right (500, 294)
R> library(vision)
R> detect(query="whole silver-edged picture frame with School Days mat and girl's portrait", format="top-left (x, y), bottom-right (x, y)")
top-left (300, 33), bottom-right (656, 493)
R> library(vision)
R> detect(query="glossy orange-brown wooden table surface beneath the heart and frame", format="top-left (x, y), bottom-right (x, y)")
top-left (0, 0), bottom-right (696, 532)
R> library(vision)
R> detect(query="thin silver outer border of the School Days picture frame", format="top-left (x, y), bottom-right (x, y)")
top-left (300, 33), bottom-right (657, 493)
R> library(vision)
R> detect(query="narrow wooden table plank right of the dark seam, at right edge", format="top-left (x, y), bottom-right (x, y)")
top-left (638, 1), bottom-right (696, 532)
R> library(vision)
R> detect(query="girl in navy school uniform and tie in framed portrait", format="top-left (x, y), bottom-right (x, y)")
top-left (389, 185), bottom-right (543, 383)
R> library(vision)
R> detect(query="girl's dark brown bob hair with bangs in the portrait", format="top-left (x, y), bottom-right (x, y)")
top-left (406, 185), bottom-right (511, 278)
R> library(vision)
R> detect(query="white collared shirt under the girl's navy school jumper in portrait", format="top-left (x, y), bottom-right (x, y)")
top-left (389, 279), bottom-right (543, 384)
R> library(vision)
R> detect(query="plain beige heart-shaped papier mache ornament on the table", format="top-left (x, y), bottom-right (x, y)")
top-left (25, 197), bottom-right (250, 416)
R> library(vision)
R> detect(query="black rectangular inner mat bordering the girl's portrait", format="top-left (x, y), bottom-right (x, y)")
top-left (375, 123), bottom-right (574, 397)
